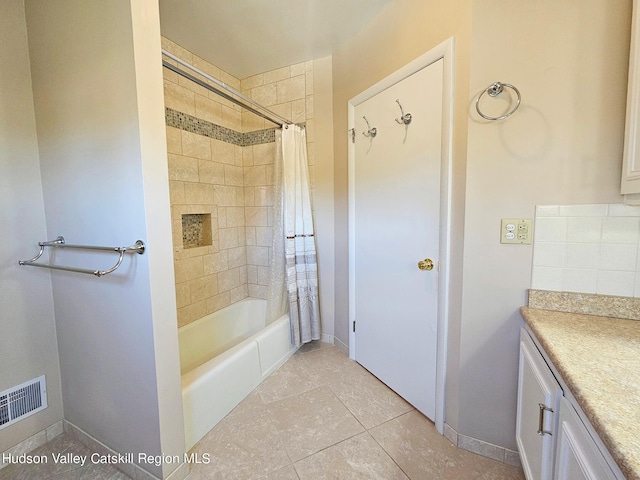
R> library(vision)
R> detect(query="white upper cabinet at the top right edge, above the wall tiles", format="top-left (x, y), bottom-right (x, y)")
top-left (620, 0), bottom-right (640, 201)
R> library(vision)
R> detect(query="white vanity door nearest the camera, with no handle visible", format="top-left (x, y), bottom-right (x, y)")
top-left (554, 398), bottom-right (616, 480)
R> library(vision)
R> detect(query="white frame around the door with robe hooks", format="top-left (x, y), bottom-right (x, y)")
top-left (347, 37), bottom-right (454, 435)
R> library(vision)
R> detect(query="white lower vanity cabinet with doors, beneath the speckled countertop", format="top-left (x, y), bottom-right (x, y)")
top-left (516, 328), bottom-right (624, 480)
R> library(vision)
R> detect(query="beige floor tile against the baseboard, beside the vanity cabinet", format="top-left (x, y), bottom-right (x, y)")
top-left (370, 410), bottom-right (498, 480)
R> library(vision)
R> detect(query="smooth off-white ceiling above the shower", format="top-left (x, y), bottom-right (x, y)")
top-left (160, 0), bottom-right (391, 79)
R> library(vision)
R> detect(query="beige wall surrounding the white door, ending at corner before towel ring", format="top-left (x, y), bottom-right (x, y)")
top-left (333, 0), bottom-right (471, 432)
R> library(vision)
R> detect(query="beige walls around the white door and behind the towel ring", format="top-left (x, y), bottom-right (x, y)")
top-left (333, 0), bottom-right (631, 450)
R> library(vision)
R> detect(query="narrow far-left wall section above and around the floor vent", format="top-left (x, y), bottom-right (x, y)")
top-left (0, 0), bottom-right (62, 453)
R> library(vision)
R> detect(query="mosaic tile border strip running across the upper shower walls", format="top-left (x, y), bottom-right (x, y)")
top-left (165, 108), bottom-right (288, 147)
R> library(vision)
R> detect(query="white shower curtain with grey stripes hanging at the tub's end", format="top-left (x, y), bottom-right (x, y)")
top-left (267, 125), bottom-right (320, 346)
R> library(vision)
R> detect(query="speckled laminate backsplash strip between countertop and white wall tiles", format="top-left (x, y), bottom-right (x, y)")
top-left (529, 289), bottom-right (640, 320)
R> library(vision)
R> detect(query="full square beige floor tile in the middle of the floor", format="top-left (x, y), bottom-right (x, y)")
top-left (267, 387), bottom-right (364, 462)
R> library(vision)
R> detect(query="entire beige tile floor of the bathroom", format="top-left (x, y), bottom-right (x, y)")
top-left (0, 342), bottom-right (524, 480)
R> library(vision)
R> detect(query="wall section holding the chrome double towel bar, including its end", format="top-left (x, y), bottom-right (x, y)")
top-left (26, 0), bottom-right (184, 478)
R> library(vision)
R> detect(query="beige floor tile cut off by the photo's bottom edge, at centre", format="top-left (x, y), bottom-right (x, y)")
top-left (294, 432), bottom-right (408, 480)
